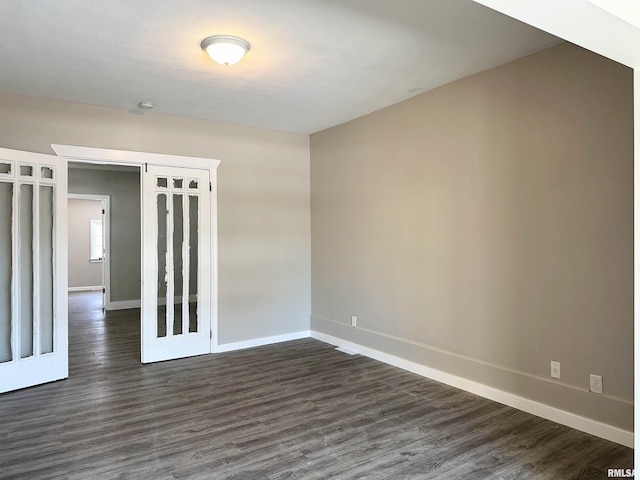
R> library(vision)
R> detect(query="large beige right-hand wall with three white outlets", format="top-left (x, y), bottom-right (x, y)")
top-left (311, 44), bottom-right (633, 430)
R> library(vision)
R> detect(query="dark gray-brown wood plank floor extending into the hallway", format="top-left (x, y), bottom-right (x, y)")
top-left (0, 294), bottom-right (633, 480)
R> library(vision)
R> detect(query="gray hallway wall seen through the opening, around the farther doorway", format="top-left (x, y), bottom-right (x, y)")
top-left (69, 168), bottom-right (140, 302)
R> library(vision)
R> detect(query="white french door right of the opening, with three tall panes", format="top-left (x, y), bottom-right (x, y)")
top-left (141, 165), bottom-right (211, 363)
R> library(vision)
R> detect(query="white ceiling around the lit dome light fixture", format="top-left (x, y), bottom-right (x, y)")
top-left (0, 0), bottom-right (560, 133)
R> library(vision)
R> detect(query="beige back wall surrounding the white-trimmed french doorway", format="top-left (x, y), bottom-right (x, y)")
top-left (0, 95), bottom-right (310, 343)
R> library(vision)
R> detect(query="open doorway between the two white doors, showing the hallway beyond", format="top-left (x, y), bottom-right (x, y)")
top-left (68, 162), bottom-right (141, 364)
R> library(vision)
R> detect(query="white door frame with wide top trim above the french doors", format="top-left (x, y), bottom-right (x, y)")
top-left (51, 144), bottom-right (220, 353)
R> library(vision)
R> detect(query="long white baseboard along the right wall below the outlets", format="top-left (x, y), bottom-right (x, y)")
top-left (311, 330), bottom-right (633, 448)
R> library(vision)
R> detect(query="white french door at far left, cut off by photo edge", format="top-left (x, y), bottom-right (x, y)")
top-left (0, 148), bottom-right (68, 392)
